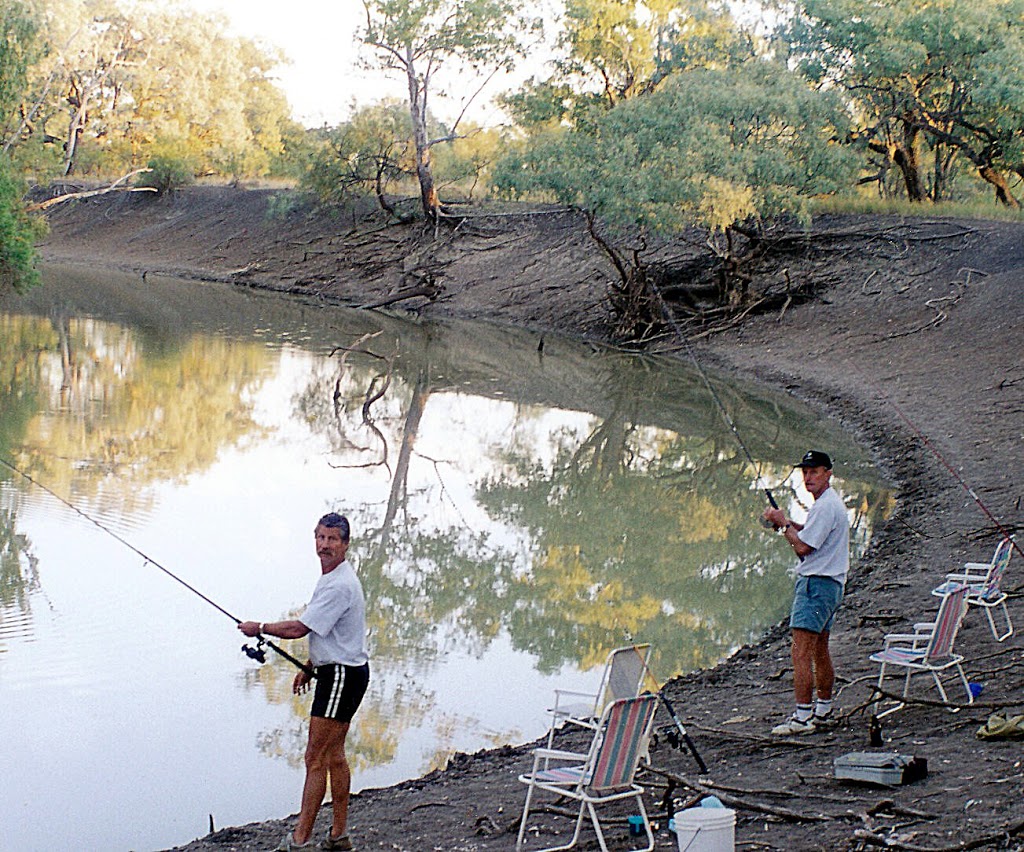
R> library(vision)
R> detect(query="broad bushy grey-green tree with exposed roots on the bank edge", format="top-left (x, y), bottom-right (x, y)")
top-left (496, 59), bottom-right (855, 338)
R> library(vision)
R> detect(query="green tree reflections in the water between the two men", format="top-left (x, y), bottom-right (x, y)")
top-left (298, 339), bottom-right (888, 753)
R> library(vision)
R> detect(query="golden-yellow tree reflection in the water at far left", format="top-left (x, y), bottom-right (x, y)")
top-left (0, 312), bottom-right (267, 513)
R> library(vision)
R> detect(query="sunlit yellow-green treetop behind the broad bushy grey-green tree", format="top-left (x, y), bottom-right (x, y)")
top-left (503, 0), bottom-right (754, 128)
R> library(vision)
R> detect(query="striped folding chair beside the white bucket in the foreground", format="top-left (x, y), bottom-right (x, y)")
top-left (516, 693), bottom-right (657, 852)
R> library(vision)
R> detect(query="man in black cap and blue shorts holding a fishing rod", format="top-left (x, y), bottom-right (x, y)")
top-left (764, 450), bottom-right (850, 736)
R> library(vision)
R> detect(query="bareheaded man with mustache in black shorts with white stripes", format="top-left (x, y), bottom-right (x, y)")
top-left (239, 512), bottom-right (370, 852)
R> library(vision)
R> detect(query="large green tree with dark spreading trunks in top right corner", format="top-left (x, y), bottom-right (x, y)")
top-left (782, 0), bottom-right (1024, 207)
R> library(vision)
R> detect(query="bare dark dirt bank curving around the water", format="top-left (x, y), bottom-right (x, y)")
top-left (34, 187), bottom-right (1024, 852)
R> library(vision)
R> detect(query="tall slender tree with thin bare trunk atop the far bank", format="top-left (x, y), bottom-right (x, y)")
top-left (362, 0), bottom-right (538, 218)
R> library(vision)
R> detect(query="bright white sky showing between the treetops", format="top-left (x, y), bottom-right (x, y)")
top-left (179, 0), bottom-right (544, 127)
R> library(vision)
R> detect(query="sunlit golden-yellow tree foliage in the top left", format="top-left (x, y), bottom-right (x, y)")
top-left (0, 0), bottom-right (296, 180)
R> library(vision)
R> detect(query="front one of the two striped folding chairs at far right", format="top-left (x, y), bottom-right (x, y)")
top-left (869, 583), bottom-right (974, 717)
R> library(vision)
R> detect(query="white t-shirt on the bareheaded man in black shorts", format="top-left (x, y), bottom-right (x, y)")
top-left (299, 560), bottom-right (370, 666)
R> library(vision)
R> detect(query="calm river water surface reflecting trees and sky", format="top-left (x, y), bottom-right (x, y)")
top-left (0, 268), bottom-right (891, 850)
